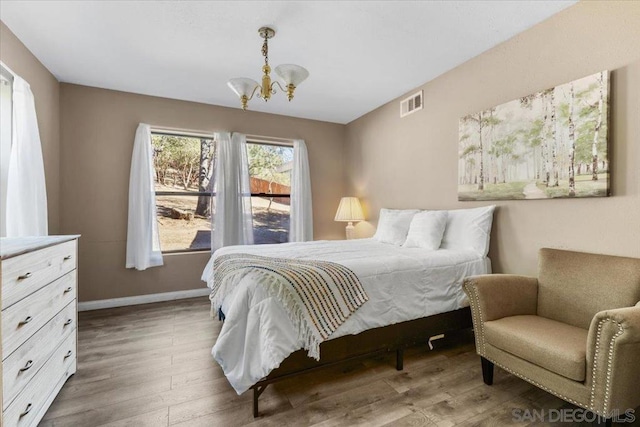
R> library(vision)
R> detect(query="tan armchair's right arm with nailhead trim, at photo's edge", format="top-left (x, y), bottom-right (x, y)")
top-left (586, 303), bottom-right (640, 414)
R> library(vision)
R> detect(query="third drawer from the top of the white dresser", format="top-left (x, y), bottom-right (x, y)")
top-left (2, 301), bottom-right (76, 409)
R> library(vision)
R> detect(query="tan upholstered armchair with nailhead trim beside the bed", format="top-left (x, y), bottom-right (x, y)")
top-left (464, 249), bottom-right (640, 424)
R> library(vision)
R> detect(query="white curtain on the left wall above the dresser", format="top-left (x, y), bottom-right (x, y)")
top-left (4, 74), bottom-right (48, 237)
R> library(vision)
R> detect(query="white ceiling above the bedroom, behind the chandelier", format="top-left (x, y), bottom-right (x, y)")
top-left (0, 0), bottom-right (575, 123)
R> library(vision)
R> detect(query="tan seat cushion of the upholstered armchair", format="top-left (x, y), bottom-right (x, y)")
top-left (484, 315), bottom-right (589, 381)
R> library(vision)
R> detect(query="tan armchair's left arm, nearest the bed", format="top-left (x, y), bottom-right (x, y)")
top-left (463, 274), bottom-right (538, 322)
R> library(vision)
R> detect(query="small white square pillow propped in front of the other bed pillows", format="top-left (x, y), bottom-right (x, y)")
top-left (440, 205), bottom-right (495, 257)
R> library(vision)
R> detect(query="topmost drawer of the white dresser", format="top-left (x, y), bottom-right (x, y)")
top-left (2, 240), bottom-right (77, 310)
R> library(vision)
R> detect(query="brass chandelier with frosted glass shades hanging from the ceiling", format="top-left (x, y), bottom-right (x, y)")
top-left (227, 27), bottom-right (309, 110)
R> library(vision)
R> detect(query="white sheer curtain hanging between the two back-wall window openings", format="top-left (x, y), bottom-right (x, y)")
top-left (211, 132), bottom-right (253, 251)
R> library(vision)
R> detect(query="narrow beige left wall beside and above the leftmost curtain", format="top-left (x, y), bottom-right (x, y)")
top-left (0, 21), bottom-right (60, 234)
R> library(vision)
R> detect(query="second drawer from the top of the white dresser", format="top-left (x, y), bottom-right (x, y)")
top-left (2, 270), bottom-right (76, 360)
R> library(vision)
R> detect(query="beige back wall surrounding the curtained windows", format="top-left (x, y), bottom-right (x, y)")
top-left (60, 84), bottom-right (345, 301)
